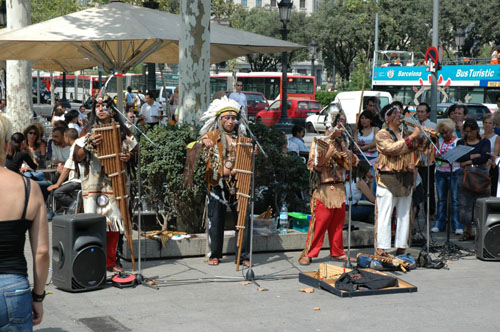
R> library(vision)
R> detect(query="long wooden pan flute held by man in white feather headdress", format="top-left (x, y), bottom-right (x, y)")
top-left (234, 137), bottom-right (253, 271)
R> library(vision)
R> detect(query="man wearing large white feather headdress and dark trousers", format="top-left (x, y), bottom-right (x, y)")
top-left (200, 96), bottom-right (250, 266)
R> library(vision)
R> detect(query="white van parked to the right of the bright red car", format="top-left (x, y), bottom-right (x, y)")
top-left (333, 91), bottom-right (392, 124)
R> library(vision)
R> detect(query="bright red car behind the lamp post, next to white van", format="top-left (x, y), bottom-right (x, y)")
top-left (256, 99), bottom-right (321, 127)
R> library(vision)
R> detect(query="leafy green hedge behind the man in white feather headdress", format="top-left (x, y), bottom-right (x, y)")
top-left (136, 124), bottom-right (309, 233)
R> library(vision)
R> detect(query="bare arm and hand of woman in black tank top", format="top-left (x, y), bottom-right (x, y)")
top-left (28, 180), bottom-right (50, 325)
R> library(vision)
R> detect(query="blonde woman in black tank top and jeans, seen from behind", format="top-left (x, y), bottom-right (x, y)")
top-left (0, 114), bottom-right (50, 331)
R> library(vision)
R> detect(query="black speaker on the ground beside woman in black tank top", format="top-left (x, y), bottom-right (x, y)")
top-left (52, 214), bottom-right (106, 292)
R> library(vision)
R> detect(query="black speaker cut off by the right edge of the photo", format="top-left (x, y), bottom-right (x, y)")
top-left (474, 197), bottom-right (500, 261)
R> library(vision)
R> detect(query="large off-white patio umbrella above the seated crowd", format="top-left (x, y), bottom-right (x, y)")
top-left (0, 1), bottom-right (304, 110)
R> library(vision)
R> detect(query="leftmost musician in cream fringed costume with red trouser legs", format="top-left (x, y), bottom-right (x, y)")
top-left (74, 98), bottom-right (137, 272)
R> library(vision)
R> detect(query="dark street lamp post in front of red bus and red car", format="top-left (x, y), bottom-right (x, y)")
top-left (276, 0), bottom-right (293, 134)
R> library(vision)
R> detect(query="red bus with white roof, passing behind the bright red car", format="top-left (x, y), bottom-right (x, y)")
top-left (210, 72), bottom-right (316, 102)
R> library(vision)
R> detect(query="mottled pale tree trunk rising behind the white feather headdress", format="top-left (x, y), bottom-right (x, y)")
top-left (178, 0), bottom-right (210, 124)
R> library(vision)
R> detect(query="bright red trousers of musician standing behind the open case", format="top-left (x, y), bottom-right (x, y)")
top-left (306, 200), bottom-right (345, 257)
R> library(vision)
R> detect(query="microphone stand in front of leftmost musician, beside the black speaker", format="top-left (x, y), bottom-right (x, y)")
top-left (108, 100), bottom-right (160, 290)
